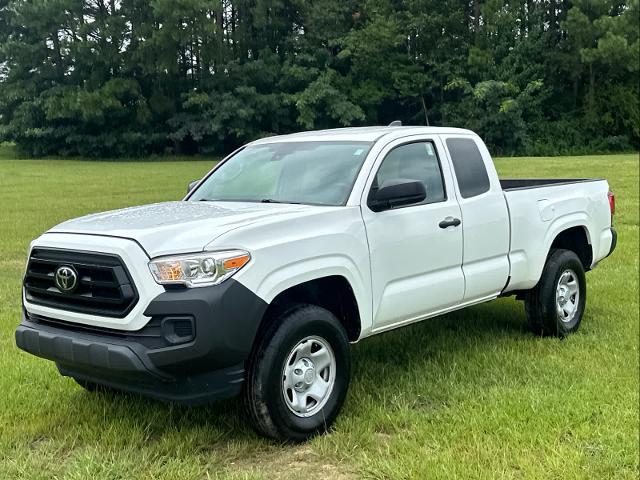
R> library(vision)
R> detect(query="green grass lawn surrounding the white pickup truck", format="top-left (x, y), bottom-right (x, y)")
top-left (0, 149), bottom-right (639, 480)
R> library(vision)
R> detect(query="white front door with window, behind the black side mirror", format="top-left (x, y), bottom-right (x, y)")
top-left (361, 138), bottom-right (464, 331)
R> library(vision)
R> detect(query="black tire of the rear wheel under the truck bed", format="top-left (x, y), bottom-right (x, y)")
top-left (524, 249), bottom-right (587, 338)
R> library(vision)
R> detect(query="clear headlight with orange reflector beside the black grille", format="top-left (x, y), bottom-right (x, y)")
top-left (149, 250), bottom-right (251, 287)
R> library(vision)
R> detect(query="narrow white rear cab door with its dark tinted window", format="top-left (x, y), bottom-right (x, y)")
top-left (444, 135), bottom-right (510, 302)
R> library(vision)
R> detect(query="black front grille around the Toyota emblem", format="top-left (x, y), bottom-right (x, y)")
top-left (24, 248), bottom-right (138, 318)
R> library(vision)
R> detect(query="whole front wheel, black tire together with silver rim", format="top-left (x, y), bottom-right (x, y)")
top-left (245, 305), bottom-right (350, 441)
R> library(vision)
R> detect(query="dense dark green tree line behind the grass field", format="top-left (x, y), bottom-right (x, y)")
top-left (0, 0), bottom-right (640, 157)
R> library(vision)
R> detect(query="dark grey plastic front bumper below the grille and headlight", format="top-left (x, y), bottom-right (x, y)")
top-left (16, 279), bottom-right (266, 404)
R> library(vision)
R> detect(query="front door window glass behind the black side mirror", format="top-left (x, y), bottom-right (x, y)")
top-left (371, 142), bottom-right (446, 203)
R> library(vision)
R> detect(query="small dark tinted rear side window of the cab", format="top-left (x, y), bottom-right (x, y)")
top-left (447, 138), bottom-right (490, 198)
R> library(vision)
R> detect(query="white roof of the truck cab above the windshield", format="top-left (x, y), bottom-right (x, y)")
top-left (251, 126), bottom-right (475, 145)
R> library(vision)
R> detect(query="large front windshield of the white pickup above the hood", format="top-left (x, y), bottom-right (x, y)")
top-left (189, 142), bottom-right (372, 205)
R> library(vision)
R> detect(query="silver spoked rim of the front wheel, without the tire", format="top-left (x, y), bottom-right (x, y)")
top-left (282, 336), bottom-right (336, 417)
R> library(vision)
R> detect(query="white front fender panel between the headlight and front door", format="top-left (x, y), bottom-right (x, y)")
top-left (207, 207), bottom-right (372, 333)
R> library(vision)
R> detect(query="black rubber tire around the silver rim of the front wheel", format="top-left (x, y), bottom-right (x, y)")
top-left (244, 305), bottom-right (351, 442)
